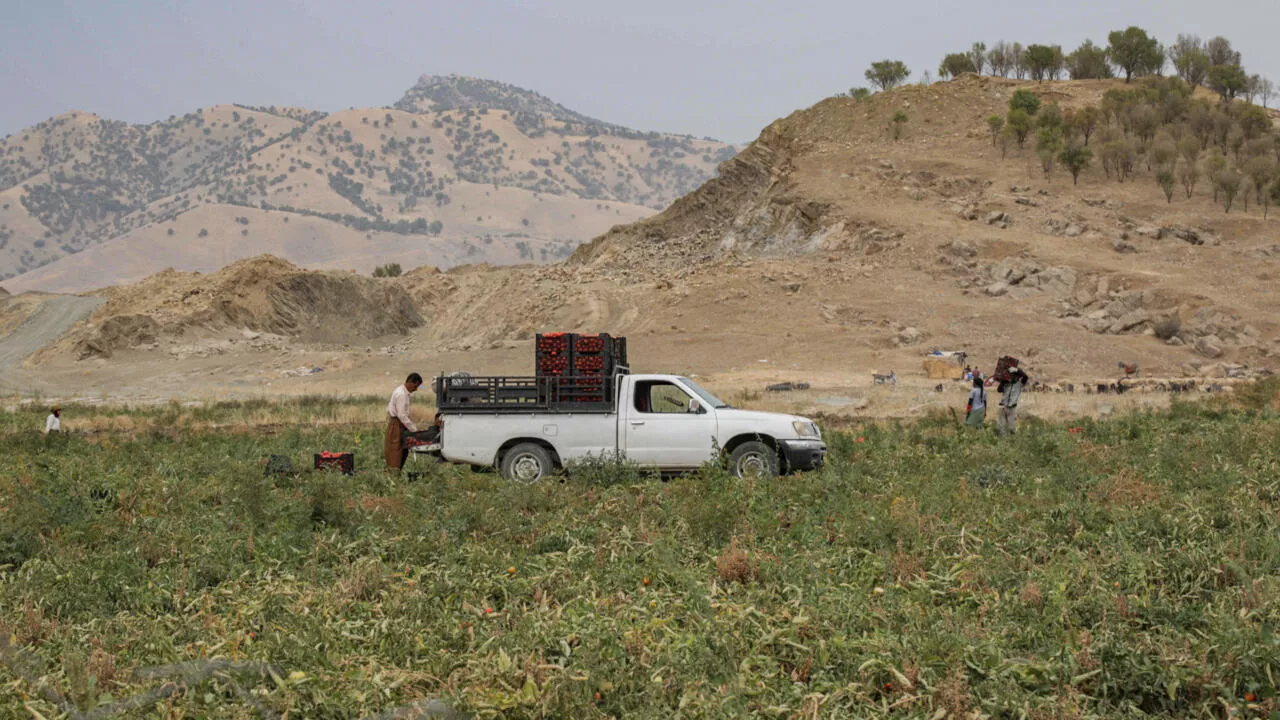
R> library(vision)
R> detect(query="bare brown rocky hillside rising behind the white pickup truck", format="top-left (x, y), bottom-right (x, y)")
top-left (5, 76), bottom-right (1280, 414)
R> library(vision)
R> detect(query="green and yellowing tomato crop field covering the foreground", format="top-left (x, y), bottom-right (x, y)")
top-left (0, 399), bottom-right (1280, 719)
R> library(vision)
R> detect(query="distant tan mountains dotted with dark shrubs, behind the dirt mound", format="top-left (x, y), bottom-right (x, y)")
top-left (0, 77), bottom-right (733, 291)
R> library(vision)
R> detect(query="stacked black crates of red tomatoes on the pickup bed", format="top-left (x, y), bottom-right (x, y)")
top-left (534, 333), bottom-right (627, 402)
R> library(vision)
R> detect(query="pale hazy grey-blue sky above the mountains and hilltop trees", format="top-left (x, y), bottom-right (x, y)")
top-left (0, 0), bottom-right (1280, 142)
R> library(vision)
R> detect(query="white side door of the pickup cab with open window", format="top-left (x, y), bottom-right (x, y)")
top-left (622, 379), bottom-right (716, 469)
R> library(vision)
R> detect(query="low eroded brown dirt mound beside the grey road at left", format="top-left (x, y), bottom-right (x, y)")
top-left (60, 255), bottom-right (422, 357)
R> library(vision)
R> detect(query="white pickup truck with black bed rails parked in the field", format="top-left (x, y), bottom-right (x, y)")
top-left (435, 373), bottom-right (827, 483)
